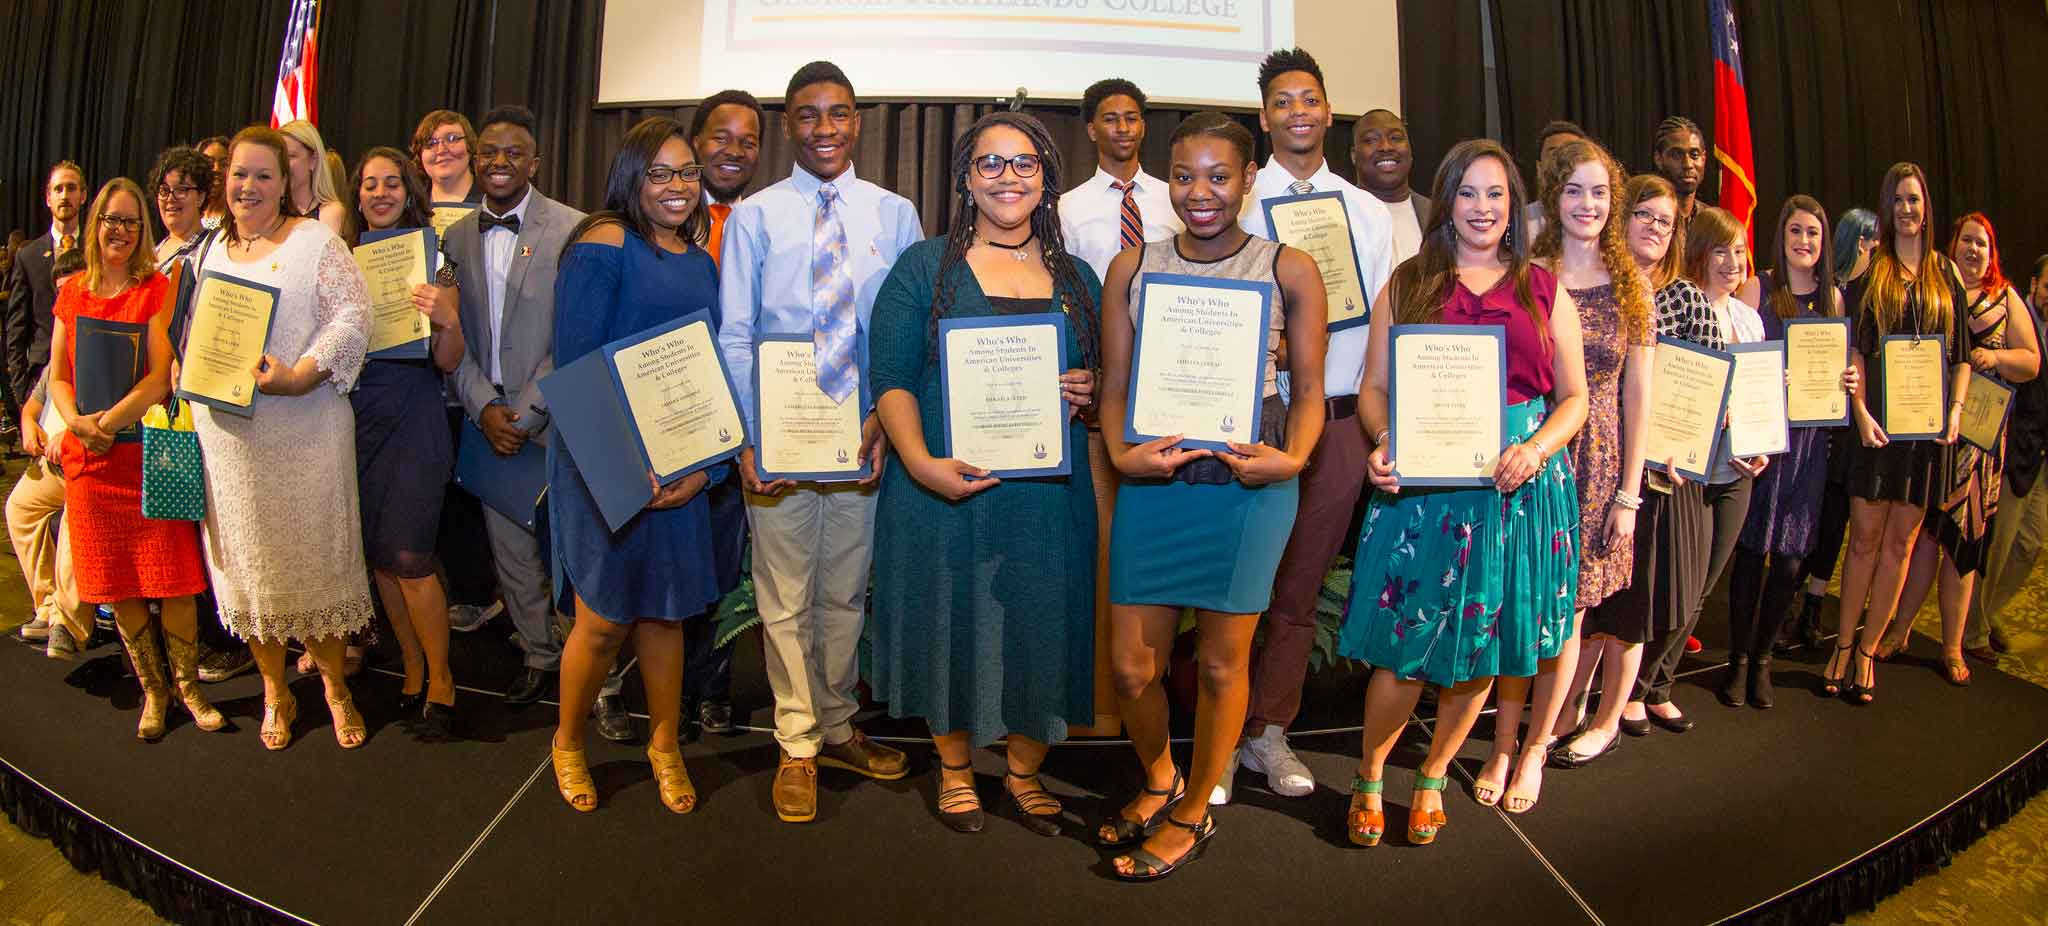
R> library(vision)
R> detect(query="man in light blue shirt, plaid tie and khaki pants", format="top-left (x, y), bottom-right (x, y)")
top-left (719, 61), bottom-right (924, 824)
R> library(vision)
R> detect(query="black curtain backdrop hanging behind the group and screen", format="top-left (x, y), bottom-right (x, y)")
top-left (0, 0), bottom-right (2048, 275)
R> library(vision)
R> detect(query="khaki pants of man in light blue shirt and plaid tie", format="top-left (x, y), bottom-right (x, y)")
top-left (748, 486), bottom-right (874, 758)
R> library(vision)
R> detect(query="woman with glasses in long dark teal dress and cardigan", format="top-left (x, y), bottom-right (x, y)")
top-left (868, 113), bottom-right (1102, 836)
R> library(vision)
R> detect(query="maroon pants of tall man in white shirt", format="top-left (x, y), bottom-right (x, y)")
top-left (1245, 397), bottom-right (1368, 735)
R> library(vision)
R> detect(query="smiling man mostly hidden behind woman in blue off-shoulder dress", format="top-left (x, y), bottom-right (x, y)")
top-left (682, 90), bottom-right (762, 733)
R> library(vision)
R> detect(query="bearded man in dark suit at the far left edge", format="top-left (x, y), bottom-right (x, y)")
top-left (6, 160), bottom-right (86, 420)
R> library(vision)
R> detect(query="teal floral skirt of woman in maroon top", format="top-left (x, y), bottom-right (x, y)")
top-left (1337, 399), bottom-right (1579, 686)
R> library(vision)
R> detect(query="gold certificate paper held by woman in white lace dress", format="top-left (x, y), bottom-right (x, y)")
top-left (178, 272), bottom-right (276, 414)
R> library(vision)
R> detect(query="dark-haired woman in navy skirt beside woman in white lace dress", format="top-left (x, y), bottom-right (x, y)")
top-left (348, 148), bottom-right (463, 740)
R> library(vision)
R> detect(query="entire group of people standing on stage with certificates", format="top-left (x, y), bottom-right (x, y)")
top-left (10, 49), bottom-right (2040, 881)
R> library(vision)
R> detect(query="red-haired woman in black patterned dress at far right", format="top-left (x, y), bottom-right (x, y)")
top-left (1878, 213), bottom-right (2040, 684)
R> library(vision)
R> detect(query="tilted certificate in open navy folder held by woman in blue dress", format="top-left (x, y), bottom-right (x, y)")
top-left (541, 311), bottom-right (748, 531)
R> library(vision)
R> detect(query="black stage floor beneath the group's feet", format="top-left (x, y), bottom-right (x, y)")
top-left (0, 606), bottom-right (2048, 924)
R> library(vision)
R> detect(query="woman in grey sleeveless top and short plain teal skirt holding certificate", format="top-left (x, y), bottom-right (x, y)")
top-left (1096, 113), bottom-right (1327, 881)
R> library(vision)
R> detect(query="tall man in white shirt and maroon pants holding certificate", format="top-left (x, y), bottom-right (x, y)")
top-left (1210, 49), bottom-right (1395, 803)
